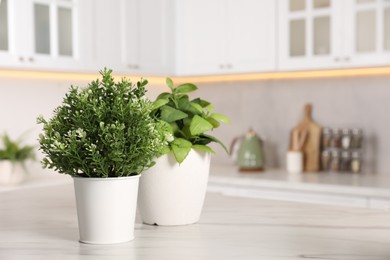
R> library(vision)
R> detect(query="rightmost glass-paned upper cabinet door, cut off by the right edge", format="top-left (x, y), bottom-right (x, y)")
top-left (343, 0), bottom-right (390, 66)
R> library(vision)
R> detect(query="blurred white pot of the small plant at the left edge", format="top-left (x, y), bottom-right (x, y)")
top-left (0, 160), bottom-right (25, 185)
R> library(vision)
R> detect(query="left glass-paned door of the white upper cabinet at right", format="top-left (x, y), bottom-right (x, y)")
top-left (278, 0), bottom-right (345, 70)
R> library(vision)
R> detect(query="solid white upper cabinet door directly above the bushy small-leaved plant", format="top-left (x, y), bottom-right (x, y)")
top-left (119, 0), bottom-right (175, 75)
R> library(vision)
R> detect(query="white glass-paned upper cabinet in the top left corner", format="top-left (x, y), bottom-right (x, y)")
top-left (0, 0), bottom-right (88, 70)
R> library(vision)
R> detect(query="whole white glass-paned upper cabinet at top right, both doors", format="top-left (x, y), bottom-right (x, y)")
top-left (278, 0), bottom-right (390, 70)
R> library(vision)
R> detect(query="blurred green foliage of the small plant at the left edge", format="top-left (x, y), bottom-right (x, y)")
top-left (0, 134), bottom-right (35, 166)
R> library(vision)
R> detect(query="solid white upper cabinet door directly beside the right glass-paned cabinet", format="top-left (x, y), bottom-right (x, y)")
top-left (224, 0), bottom-right (276, 73)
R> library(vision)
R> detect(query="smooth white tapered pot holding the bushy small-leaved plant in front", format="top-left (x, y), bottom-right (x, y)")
top-left (73, 175), bottom-right (139, 244)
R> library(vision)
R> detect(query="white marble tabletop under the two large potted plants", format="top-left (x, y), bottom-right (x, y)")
top-left (0, 183), bottom-right (390, 260)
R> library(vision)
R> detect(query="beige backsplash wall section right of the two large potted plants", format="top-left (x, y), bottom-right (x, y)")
top-left (195, 76), bottom-right (390, 174)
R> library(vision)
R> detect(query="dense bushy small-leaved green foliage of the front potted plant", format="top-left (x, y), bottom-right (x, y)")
top-left (37, 69), bottom-right (162, 177)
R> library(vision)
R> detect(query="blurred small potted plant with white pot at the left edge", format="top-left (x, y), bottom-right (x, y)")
top-left (0, 134), bottom-right (35, 184)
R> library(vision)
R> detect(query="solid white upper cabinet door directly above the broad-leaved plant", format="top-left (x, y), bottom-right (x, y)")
top-left (176, 0), bottom-right (227, 75)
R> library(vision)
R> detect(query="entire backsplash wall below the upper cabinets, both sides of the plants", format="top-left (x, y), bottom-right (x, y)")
top-left (0, 73), bottom-right (390, 174)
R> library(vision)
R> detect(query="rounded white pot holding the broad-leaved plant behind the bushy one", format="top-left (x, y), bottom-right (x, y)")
top-left (138, 149), bottom-right (210, 226)
